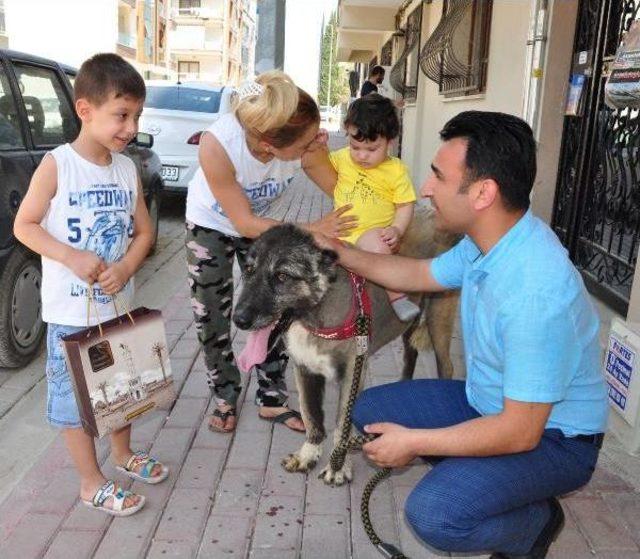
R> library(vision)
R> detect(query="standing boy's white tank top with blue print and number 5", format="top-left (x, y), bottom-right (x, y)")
top-left (41, 144), bottom-right (138, 326)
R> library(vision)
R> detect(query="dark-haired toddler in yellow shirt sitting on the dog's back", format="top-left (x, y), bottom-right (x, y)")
top-left (302, 93), bottom-right (420, 321)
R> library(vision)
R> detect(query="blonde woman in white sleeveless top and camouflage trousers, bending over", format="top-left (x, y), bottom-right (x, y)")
top-left (185, 71), bottom-right (354, 432)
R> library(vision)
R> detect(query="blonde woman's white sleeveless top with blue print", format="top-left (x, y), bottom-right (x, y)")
top-left (187, 113), bottom-right (300, 237)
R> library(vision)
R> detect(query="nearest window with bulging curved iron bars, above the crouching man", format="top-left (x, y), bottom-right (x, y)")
top-left (420, 0), bottom-right (493, 97)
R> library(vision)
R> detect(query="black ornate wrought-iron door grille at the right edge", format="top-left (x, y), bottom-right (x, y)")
top-left (552, 0), bottom-right (640, 314)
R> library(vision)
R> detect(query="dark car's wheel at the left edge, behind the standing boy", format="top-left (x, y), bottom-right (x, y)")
top-left (0, 246), bottom-right (45, 367)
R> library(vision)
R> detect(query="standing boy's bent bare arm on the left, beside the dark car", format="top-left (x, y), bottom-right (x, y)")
top-left (13, 156), bottom-right (104, 283)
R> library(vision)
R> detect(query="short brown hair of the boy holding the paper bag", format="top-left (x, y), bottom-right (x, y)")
top-left (73, 52), bottom-right (146, 105)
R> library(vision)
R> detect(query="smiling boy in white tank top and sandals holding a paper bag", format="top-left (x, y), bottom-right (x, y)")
top-left (14, 54), bottom-right (168, 516)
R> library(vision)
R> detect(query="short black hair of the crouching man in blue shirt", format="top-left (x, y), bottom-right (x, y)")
top-left (440, 111), bottom-right (536, 210)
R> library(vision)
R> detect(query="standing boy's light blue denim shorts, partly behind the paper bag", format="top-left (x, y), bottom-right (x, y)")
top-left (46, 324), bottom-right (85, 428)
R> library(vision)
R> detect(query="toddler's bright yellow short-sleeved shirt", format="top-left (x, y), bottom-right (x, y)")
top-left (329, 147), bottom-right (416, 243)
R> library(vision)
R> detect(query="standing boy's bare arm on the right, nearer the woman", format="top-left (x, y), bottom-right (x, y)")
top-left (98, 177), bottom-right (154, 295)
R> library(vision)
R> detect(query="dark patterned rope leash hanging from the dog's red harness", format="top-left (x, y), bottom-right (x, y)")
top-left (329, 287), bottom-right (409, 559)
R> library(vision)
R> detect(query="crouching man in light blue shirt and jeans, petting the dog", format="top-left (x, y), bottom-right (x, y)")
top-left (318, 111), bottom-right (607, 559)
